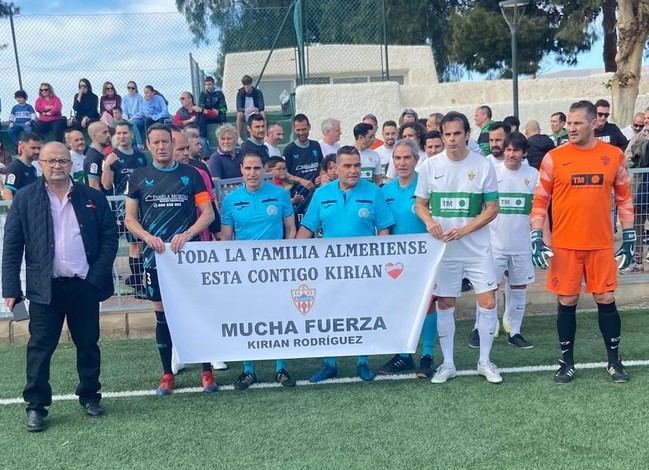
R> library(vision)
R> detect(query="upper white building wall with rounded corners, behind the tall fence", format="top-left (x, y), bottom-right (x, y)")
top-left (223, 44), bottom-right (437, 103)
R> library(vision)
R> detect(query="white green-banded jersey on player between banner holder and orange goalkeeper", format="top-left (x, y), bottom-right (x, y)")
top-left (489, 163), bottom-right (539, 255)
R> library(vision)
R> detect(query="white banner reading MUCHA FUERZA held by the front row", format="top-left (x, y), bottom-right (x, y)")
top-left (156, 234), bottom-right (444, 363)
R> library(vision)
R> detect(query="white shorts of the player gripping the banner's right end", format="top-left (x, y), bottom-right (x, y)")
top-left (433, 254), bottom-right (498, 297)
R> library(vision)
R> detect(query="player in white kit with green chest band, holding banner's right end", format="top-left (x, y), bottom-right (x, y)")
top-left (415, 111), bottom-right (502, 383)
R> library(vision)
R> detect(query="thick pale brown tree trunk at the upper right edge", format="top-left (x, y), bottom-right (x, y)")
top-left (610, 0), bottom-right (649, 125)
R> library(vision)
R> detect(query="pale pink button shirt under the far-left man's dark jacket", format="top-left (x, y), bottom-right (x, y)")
top-left (45, 183), bottom-right (90, 279)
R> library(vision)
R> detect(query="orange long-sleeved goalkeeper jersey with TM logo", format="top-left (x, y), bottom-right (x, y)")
top-left (532, 140), bottom-right (633, 250)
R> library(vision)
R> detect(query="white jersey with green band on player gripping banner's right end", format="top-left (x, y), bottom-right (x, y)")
top-left (415, 151), bottom-right (498, 260)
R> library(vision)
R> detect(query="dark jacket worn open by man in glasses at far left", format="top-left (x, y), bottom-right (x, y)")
top-left (2, 178), bottom-right (118, 304)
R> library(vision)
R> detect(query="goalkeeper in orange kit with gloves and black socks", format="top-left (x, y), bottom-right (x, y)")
top-left (531, 101), bottom-right (636, 384)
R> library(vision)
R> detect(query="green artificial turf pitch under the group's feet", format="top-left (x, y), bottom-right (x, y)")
top-left (0, 311), bottom-right (649, 470)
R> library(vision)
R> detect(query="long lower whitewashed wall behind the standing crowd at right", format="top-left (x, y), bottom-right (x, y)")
top-left (296, 74), bottom-right (649, 143)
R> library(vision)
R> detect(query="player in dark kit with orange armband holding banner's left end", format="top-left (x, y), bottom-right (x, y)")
top-left (125, 124), bottom-right (217, 396)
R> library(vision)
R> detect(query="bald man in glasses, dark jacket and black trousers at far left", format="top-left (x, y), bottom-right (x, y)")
top-left (2, 142), bottom-right (117, 432)
